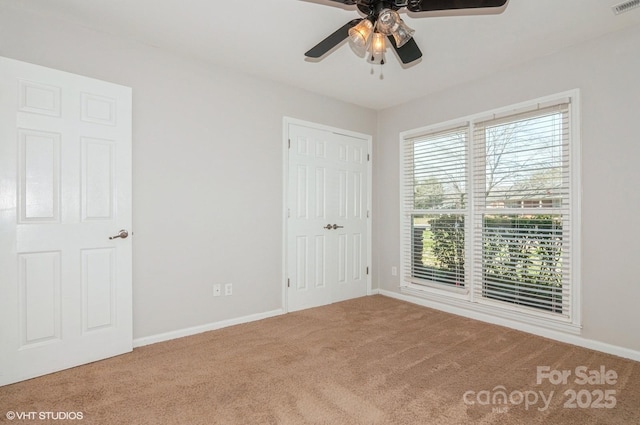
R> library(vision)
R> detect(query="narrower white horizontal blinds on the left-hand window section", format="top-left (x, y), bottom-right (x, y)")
top-left (403, 126), bottom-right (469, 287)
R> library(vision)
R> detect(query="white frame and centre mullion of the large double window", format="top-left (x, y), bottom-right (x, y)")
top-left (399, 89), bottom-right (582, 334)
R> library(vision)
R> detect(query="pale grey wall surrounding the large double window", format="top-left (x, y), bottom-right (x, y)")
top-left (374, 27), bottom-right (640, 352)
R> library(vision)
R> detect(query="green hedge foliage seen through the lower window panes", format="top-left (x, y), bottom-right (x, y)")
top-left (413, 214), bottom-right (562, 311)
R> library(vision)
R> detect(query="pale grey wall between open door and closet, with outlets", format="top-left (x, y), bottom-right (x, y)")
top-left (0, 3), bottom-right (377, 338)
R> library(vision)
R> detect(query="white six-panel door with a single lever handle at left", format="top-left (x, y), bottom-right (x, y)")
top-left (0, 58), bottom-right (133, 385)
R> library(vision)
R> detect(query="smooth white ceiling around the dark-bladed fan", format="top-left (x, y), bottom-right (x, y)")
top-left (8, 0), bottom-right (640, 109)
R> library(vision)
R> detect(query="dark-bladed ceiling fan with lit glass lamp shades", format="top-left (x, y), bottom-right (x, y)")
top-left (304, 0), bottom-right (508, 64)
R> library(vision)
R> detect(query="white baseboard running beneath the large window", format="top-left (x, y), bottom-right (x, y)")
top-left (378, 289), bottom-right (640, 361)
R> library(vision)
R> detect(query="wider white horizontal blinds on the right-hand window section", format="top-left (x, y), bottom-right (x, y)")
top-left (473, 103), bottom-right (571, 315)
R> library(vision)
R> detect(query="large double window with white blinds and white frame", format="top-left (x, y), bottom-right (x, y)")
top-left (402, 92), bottom-right (579, 332)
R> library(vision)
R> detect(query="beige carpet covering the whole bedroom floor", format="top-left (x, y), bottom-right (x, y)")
top-left (0, 296), bottom-right (640, 425)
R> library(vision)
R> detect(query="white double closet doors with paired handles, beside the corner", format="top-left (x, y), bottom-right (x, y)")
top-left (286, 123), bottom-right (370, 311)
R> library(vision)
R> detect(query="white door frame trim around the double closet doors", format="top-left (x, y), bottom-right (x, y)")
top-left (282, 116), bottom-right (373, 313)
